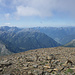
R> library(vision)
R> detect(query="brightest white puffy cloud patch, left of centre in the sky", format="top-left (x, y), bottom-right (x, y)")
top-left (16, 6), bottom-right (40, 16)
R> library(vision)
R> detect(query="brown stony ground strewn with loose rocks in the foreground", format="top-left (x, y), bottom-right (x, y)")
top-left (0, 47), bottom-right (75, 75)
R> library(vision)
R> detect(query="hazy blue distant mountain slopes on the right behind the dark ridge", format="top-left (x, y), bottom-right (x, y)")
top-left (34, 27), bottom-right (75, 45)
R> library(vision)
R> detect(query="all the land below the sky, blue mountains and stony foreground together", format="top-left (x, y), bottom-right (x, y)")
top-left (0, 26), bottom-right (75, 75)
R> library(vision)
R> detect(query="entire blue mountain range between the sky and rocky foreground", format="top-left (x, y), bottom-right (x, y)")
top-left (0, 26), bottom-right (75, 55)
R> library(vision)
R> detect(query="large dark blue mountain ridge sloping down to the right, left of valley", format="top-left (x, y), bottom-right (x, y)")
top-left (0, 27), bottom-right (60, 53)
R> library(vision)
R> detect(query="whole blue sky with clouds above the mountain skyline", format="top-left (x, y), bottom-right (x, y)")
top-left (0, 0), bottom-right (75, 27)
